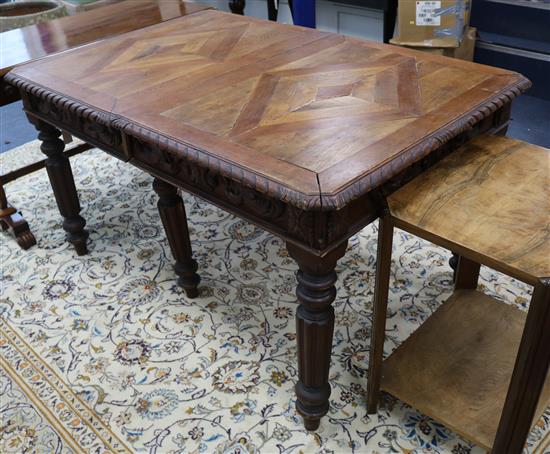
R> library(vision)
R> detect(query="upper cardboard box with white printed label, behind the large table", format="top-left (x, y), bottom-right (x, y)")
top-left (394, 0), bottom-right (471, 47)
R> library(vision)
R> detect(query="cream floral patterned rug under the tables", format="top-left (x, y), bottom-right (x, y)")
top-left (0, 143), bottom-right (550, 454)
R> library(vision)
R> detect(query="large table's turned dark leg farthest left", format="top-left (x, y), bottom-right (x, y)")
top-left (35, 121), bottom-right (88, 255)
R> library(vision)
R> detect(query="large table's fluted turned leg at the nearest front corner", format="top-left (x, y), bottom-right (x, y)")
top-left (287, 241), bottom-right (347, 430)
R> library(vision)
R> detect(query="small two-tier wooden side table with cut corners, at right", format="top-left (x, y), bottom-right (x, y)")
top-left (367, 137), bottom-right (550, 454)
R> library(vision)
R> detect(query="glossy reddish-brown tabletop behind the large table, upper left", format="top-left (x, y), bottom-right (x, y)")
top-left (0, 0), bottom-right (208, 75)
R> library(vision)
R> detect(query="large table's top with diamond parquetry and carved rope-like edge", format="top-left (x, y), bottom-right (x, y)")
top-left (7, 11), bottom-right (529, 210)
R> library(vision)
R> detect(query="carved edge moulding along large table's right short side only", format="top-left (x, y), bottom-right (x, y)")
top-left (321, 74), bottom-right (532, 211)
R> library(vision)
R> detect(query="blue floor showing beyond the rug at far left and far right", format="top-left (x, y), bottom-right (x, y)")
top-left (0, 95), bottom-right (550, 153)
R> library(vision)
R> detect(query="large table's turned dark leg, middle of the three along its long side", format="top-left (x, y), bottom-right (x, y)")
top-left (153, 178), bottom-right (201, 298)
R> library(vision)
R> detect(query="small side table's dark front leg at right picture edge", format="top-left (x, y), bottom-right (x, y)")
top-left (492, 278), bottom-right (550, 454)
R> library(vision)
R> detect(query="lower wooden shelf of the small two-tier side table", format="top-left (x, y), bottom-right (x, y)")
top-left (381, 290), bottom-right (550, 449)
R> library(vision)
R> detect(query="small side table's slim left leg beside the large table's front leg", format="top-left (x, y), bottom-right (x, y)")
top-left (367, 214), bottom-right (393, 413)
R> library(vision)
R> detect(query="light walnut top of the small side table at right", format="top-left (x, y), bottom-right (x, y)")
top-left (388, 137), bottom-right (550, 283)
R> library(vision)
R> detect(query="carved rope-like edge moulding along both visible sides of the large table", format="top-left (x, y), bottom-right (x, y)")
top-left (5, 72), bottom-right (531, 211)
